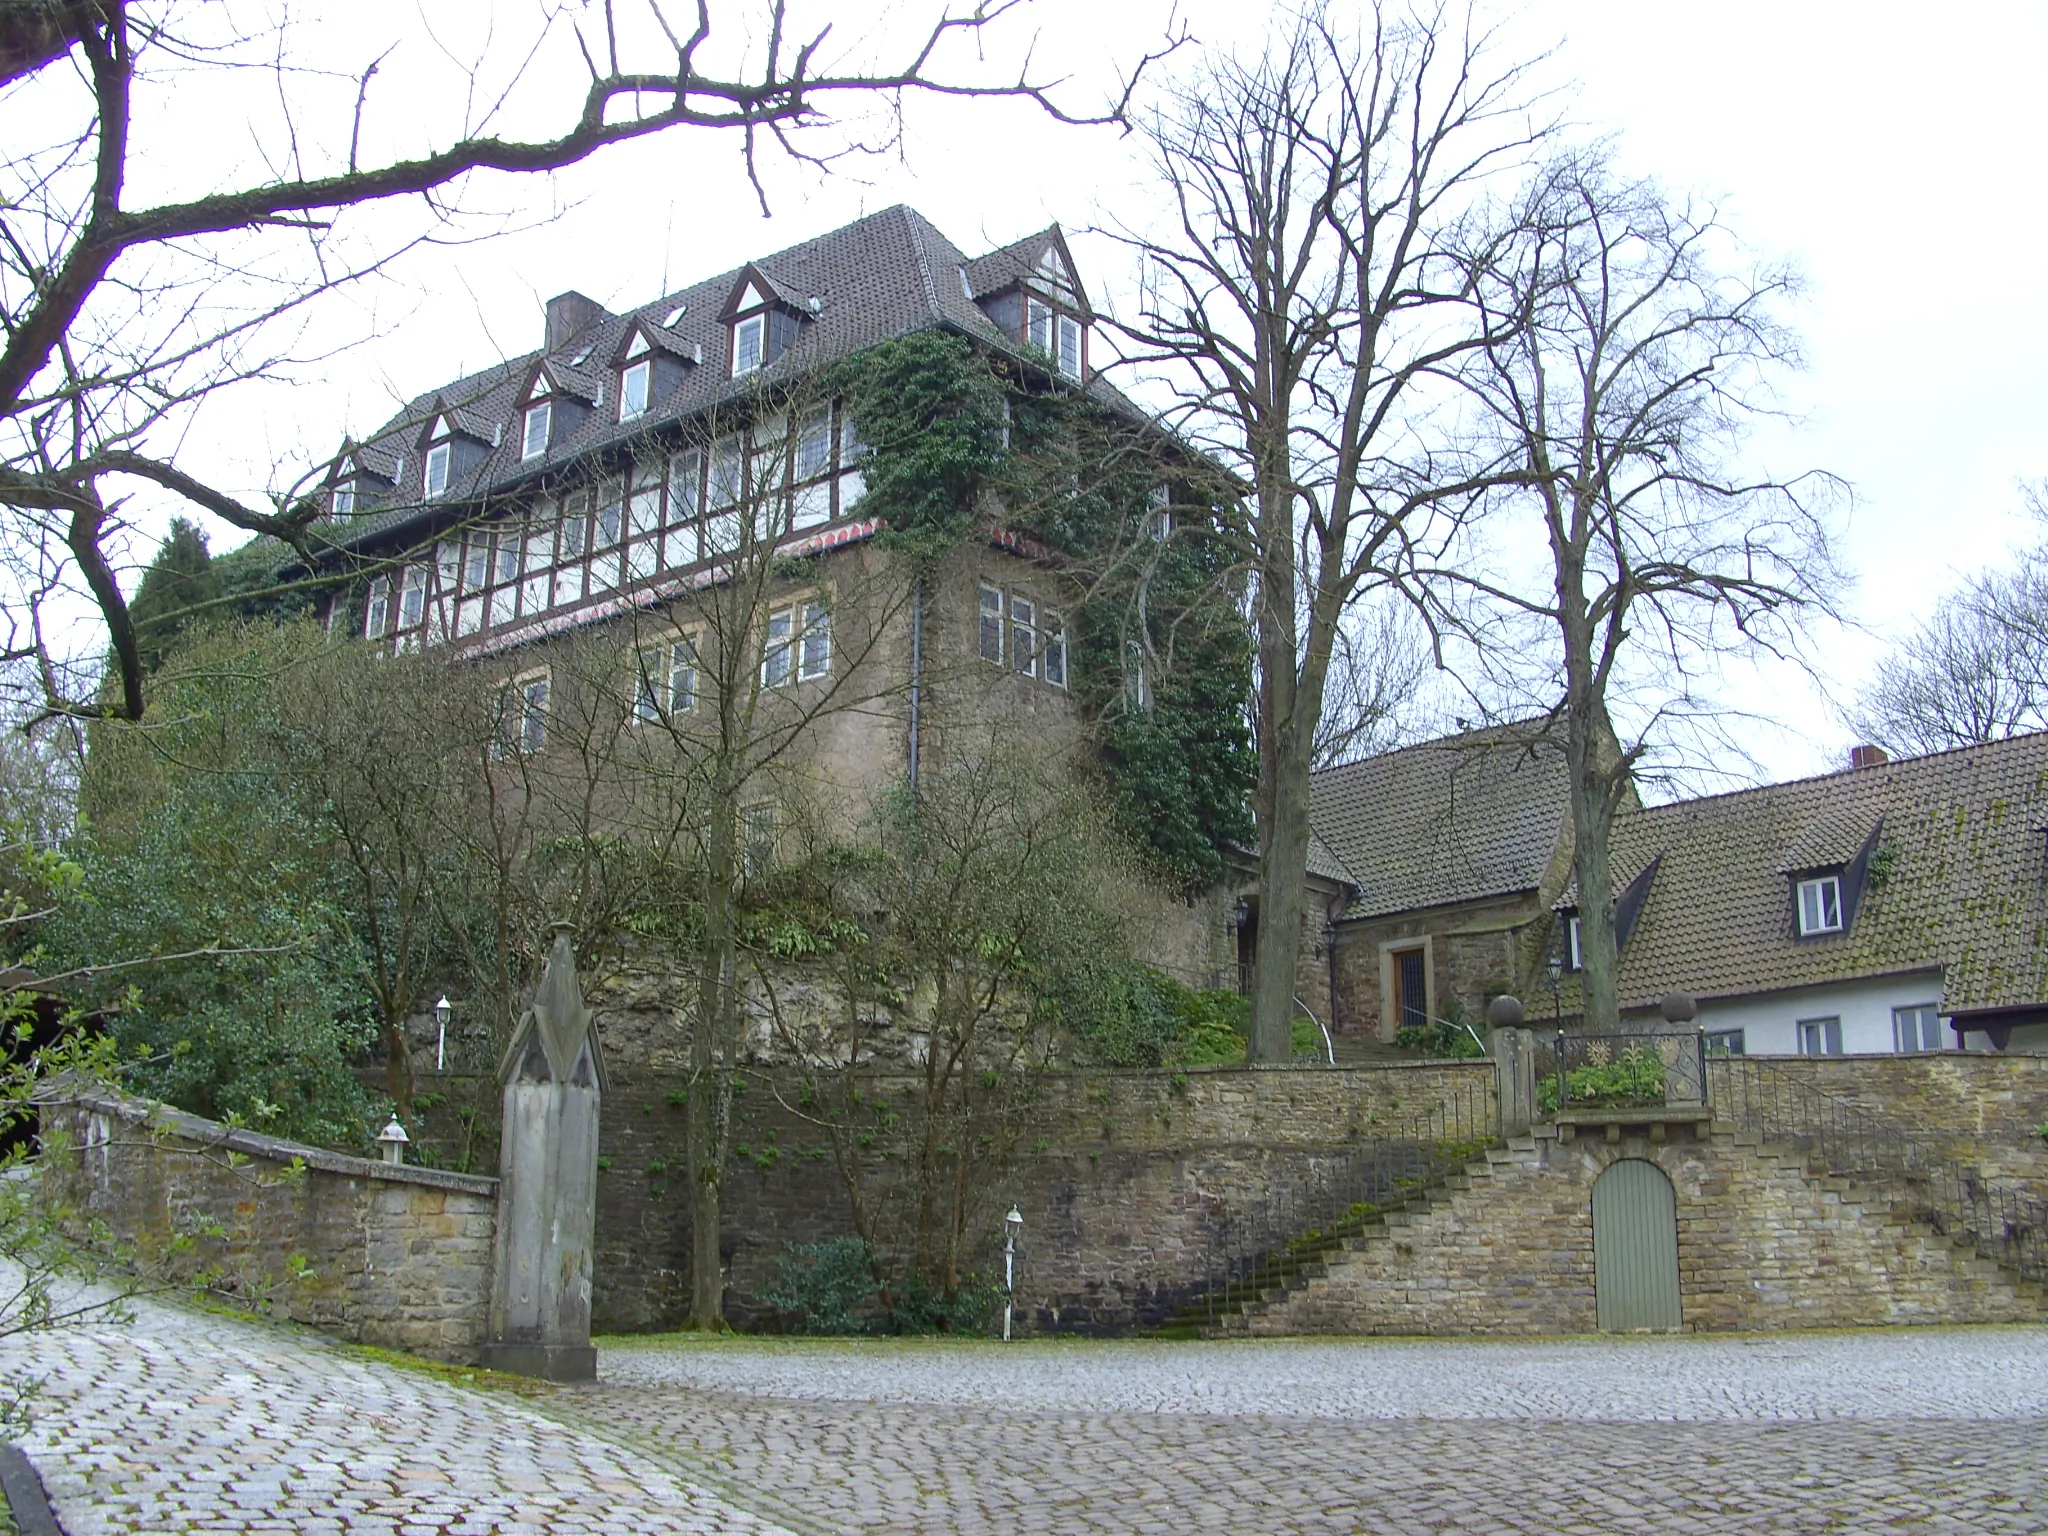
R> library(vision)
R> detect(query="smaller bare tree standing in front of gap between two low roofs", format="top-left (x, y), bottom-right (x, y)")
top-left (1446, 150), bottom-right (1835, 1030)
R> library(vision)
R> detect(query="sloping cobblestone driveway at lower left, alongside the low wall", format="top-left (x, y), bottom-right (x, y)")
top-left (0, 1305), bottom-right (798, 1536)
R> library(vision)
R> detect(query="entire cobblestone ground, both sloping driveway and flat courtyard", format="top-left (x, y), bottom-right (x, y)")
top-left (8, 1307), bottom-right (2048, 1536)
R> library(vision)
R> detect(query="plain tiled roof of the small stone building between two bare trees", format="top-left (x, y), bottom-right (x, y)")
top-left (1309, 721), bottom-right (1571, 918)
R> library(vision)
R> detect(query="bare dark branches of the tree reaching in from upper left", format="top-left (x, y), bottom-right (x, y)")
top-left (0, 0), bottom-right (1171, 719)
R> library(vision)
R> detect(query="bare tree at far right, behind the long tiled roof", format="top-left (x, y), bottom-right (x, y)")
top-left (1847, 485), bottom-right (2048, 752)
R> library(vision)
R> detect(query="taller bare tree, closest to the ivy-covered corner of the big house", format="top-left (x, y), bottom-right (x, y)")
top-left (1120, 4), bottom-right (1542, 1063)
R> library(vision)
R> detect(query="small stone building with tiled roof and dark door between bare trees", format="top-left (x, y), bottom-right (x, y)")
top-left (1309, 721), bottom-right (1571, 1040)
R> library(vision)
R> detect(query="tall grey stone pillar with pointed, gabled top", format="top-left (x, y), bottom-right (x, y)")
top-left (483, 926), bottom-right (604, 1380)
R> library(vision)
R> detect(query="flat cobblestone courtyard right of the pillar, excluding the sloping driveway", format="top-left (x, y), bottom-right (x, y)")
top-left (555, 1329), bottom-right (2048, 1536)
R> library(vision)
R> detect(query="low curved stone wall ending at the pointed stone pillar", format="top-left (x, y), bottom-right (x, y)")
top-left (41, 1094), bottom-right (498, 1362)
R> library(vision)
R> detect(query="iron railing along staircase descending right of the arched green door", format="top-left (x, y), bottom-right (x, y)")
top-left (1712, 1057), bottom-right (2048, 1280)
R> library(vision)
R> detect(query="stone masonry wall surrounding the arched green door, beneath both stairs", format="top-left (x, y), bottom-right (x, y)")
top-left (1251, 1128), bottom-right (2044, 1333)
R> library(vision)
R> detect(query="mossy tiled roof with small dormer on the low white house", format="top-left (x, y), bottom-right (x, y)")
top-left (1614, 733), bottom-right (2048, 1008)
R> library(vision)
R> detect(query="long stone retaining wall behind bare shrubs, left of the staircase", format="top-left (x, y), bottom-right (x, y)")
top-left (399, 1061), bottom-right (1493, 1331)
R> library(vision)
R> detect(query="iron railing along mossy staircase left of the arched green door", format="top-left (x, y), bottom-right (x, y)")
top-left (1161, 1081), bottom-right (1499, 1327)
